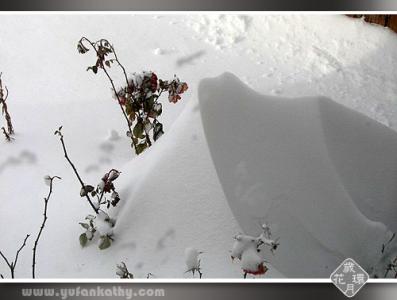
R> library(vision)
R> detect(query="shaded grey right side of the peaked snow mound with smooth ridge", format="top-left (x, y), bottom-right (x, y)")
top-left (199, 73), bottom-right (397, 277)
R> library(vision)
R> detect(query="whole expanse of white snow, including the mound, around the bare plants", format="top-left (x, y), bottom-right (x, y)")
top-left (0, 14), bottom-right (397, 278)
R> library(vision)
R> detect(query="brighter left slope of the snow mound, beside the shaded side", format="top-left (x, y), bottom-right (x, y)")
top-left (111, 101), bottom-right (282, 278)
